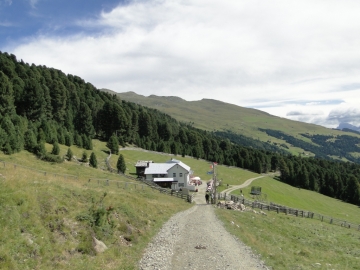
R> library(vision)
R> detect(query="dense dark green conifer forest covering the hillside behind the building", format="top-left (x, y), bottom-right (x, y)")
top-left (0, 53), bottom-right (360, 204)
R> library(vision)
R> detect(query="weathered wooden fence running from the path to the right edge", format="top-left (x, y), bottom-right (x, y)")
top-left (217, 193), bottom-right (360, 231)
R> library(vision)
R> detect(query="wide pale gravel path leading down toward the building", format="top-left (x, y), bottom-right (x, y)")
top-left (139, 179), bottom-right (268, 270)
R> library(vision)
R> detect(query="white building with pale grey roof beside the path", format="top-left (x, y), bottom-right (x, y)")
top-left (144, 159), bottom-right (195, 190)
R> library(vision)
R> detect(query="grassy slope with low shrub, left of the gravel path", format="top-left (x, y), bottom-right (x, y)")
top-left (0, 141), bottom-right (191, 269)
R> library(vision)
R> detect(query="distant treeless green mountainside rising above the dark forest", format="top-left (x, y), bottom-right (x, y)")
top-left (111, 89), bottom-right (358, 155)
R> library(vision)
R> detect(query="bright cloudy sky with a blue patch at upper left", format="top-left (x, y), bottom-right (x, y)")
top-left (0, 0), bottom-right (360, 128)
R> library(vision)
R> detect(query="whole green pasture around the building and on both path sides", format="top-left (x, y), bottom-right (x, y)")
top-left (0, 146), bottom-right (360, 269)
